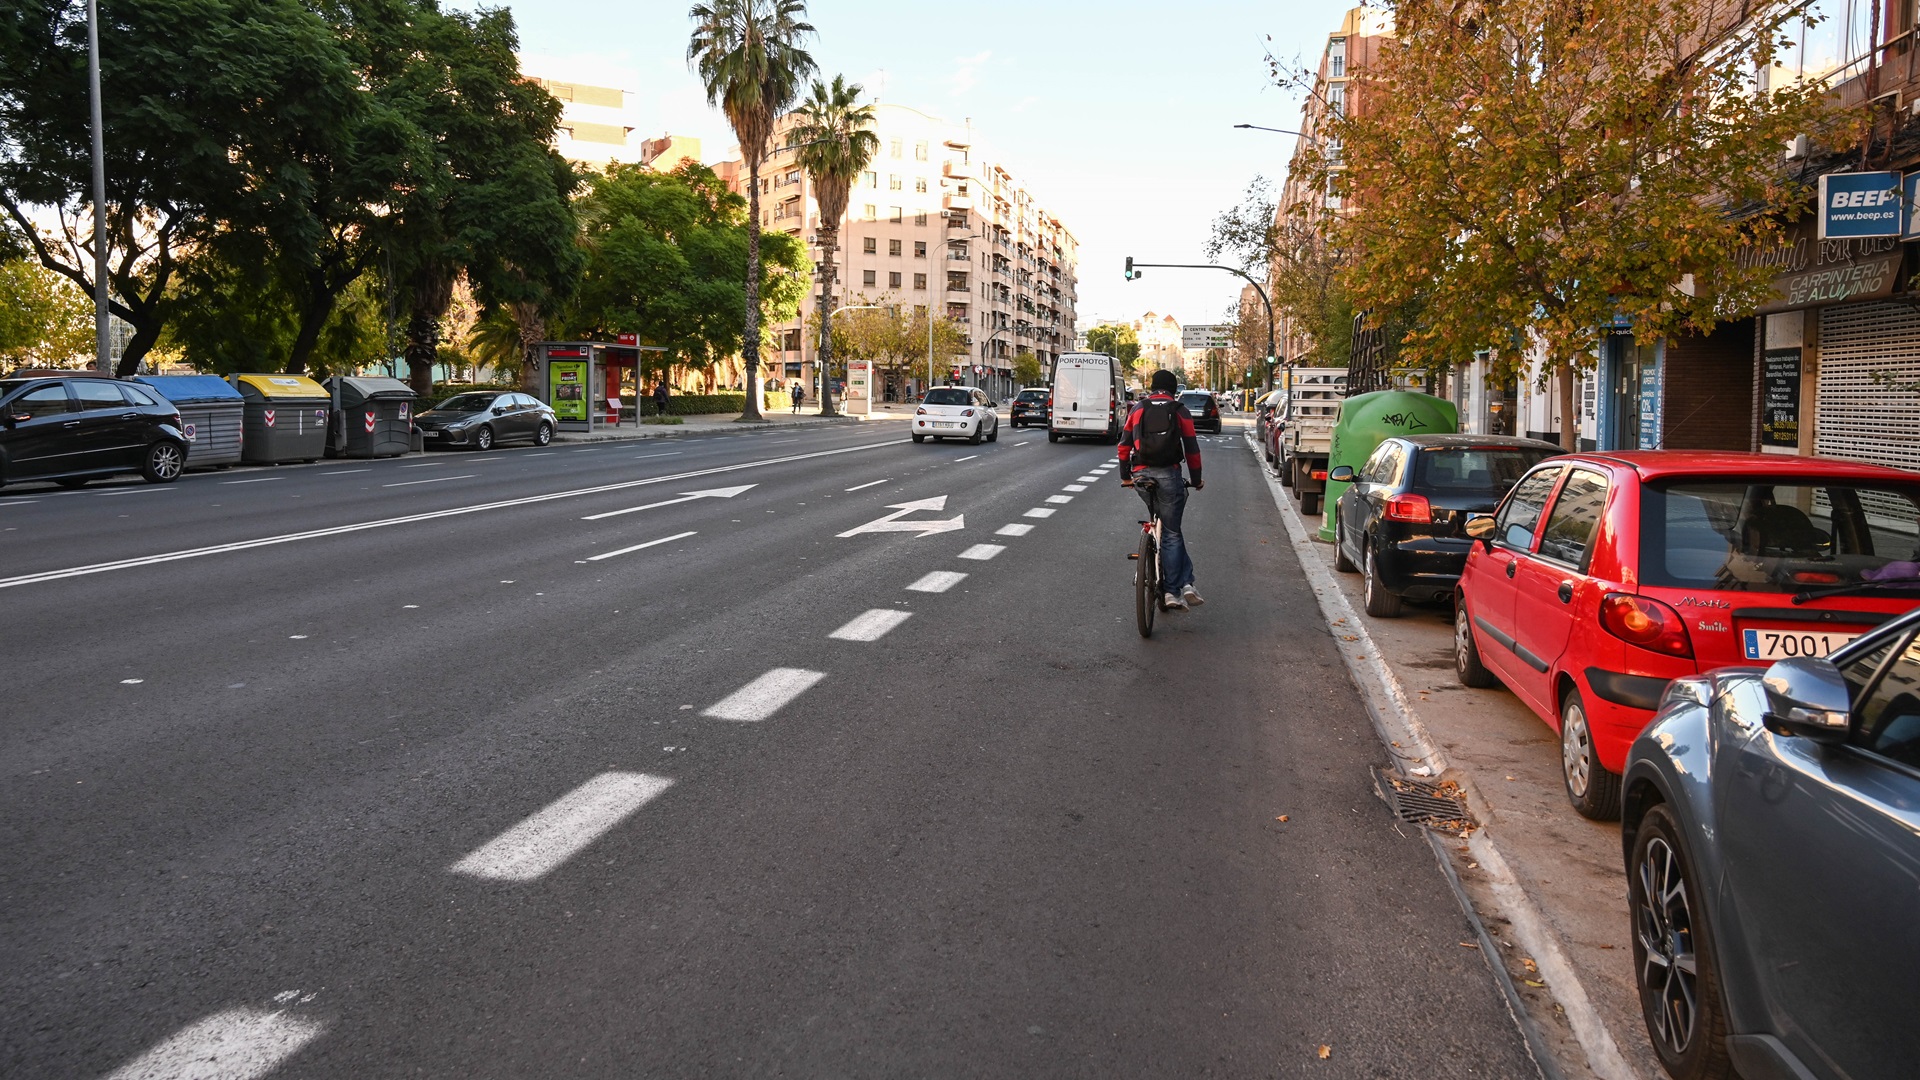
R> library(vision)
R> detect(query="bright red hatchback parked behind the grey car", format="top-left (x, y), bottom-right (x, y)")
top-left (1453, 450), bottom-right (1920, 821)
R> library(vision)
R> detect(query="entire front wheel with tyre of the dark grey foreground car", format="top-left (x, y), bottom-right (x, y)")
top-left (1626, 805), bottom-right (1732, 1080)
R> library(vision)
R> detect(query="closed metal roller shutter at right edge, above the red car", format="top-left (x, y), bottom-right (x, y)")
top-left (1814, 304), bottom-right (1920, 473)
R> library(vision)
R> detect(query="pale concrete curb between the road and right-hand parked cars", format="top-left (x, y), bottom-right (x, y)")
top-left (1248, 428), bottom-right (1642, 1080)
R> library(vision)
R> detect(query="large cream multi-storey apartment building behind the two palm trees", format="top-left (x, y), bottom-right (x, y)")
top-left (716, 104), bottom-right (1079, 400)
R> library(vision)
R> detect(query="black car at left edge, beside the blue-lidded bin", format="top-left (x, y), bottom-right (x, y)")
top-left (0, 375), bottom-right (188, 488)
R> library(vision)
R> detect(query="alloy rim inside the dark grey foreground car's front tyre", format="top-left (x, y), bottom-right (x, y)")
top-left (1634, 838), bottom-right (1699, 1057)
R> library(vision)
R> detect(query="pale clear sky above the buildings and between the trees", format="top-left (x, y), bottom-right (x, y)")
top-left (495, 0), bottom-right (1354, 325)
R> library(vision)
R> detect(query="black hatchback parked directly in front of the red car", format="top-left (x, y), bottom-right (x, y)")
top-left (1327, 434), bottom-right (1563, 619)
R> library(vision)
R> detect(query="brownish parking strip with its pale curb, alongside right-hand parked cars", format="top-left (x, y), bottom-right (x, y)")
top-left (1250, 428), bottom-right (1665, 1080)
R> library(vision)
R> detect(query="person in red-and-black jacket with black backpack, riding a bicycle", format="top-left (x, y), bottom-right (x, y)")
top-left (1119, 369), bottom-right (1206, 611)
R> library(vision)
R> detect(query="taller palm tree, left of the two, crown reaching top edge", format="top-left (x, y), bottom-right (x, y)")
top-left (687, 0), bottom-right (814, 421)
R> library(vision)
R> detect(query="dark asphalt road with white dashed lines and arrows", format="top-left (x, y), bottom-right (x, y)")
top-left (0, 423), bottom-right (1534, 1078)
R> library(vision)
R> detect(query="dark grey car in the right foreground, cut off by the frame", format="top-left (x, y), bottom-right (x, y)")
top-left (1620, 613), bottom-right (1920, 1080)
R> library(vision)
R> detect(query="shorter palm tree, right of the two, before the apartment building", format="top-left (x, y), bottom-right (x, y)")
top-left (787, 75), bottom-right (879, 417)
